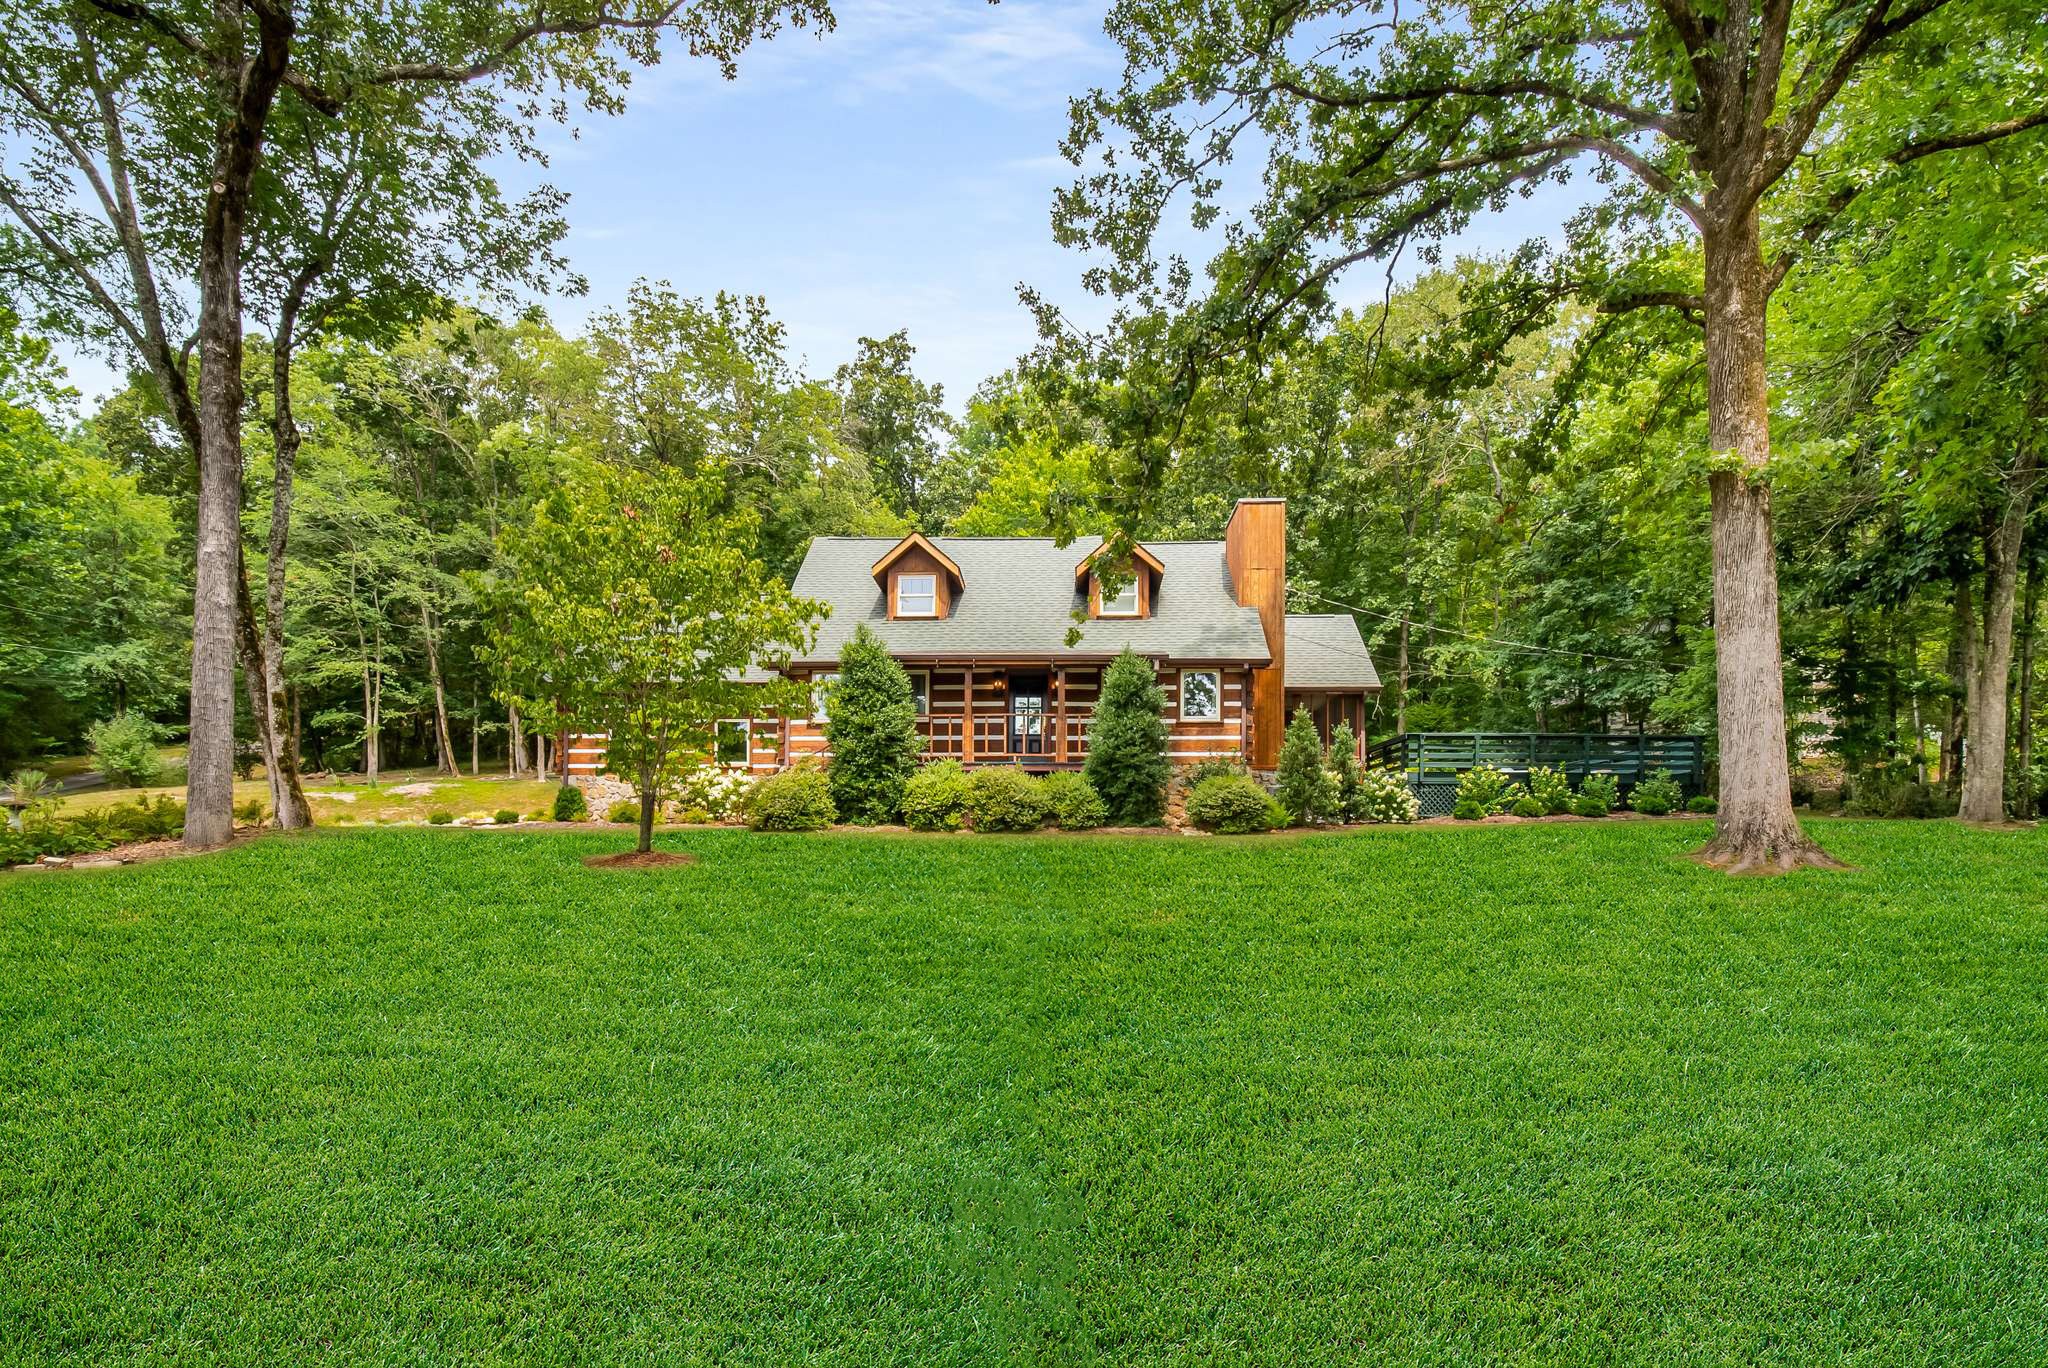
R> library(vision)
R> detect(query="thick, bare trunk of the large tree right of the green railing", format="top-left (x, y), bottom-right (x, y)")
top-left (1700, 210), bottom-right (1835, 872)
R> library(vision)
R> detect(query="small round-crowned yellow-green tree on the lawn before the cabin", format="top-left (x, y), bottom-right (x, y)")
top-left (485, 465), bottom-right (825, 852)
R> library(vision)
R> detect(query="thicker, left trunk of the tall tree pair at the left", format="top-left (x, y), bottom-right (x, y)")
top-left (184, 4), bottom-right (293, 850)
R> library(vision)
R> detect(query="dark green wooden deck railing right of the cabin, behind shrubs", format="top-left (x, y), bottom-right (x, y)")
top-left (1366, 731), bottom-right (1706, 817)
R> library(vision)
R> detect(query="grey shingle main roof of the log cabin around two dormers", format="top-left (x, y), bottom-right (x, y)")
top-left (793, 537), bottom-right (1272, 664)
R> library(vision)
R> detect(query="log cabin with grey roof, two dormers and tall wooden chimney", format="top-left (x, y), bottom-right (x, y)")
top-left (567, 500), bottom-right (1380, 776)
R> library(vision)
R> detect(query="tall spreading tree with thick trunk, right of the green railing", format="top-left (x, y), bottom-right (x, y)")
top-left (1040, 0), bottom-right (2048, 868)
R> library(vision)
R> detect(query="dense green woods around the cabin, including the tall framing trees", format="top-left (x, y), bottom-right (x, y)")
top-left (0, 0), bottom-right (2048, 862)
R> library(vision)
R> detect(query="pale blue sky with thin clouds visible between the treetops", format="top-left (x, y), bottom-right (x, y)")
top-left (51, 0), bottom-right (1571, 412)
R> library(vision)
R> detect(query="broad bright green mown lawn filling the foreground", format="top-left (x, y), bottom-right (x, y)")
top-left (0, 821), bottom-right (2048, 1364)
